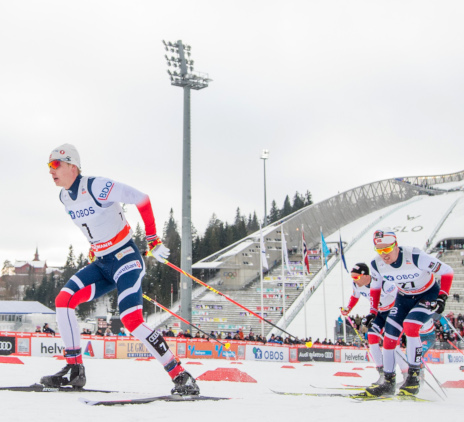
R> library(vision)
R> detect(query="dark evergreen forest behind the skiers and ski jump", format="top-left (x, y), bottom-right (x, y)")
top-left (24, 191), bottom-right (312, 319)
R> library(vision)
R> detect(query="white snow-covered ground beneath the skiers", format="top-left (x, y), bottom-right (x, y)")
top-left (0, 357), bottom-right (464, 422)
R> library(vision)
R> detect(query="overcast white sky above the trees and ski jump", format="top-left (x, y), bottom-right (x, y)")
top-left (0, 0), bottom-right (464, 265)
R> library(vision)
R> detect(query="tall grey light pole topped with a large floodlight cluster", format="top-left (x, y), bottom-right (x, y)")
top-left (163, 40), bottom-right (211, 330)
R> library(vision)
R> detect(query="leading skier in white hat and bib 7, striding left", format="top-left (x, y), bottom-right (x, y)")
top-left (41, 144), bottom-right (200, 395)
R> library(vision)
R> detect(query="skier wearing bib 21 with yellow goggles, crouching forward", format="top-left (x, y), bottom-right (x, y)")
top-left (366, 229), bottom-right (454, 396)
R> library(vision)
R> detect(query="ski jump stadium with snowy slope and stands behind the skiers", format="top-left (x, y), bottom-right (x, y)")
top-left (156, 171), bottom-right (464, 340)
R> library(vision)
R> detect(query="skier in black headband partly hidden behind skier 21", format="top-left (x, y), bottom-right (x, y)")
top-left (340, 262), bottom-right (408, 386)
